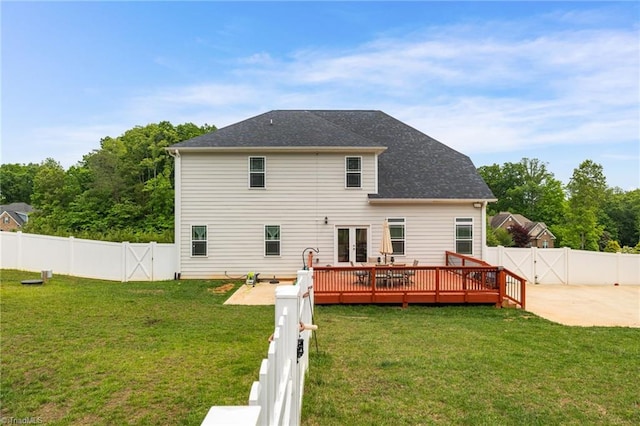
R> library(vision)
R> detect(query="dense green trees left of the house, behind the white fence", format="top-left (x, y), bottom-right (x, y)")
top-left (0, 121), bottom-right (216, 242)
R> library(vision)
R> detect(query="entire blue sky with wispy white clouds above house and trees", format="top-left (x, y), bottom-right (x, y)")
top-left (0, 1), bottom-right (640, 190)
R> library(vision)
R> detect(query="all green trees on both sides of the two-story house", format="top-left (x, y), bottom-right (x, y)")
top-left (0, 121), bottom-right (640, 252)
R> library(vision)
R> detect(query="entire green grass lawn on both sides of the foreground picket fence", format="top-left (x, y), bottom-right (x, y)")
top-left (0, 271), bottom-right (640, 425)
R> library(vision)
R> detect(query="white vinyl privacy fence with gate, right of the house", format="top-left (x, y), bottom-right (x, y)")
top-left (484, 246), bottom-right (640, 285)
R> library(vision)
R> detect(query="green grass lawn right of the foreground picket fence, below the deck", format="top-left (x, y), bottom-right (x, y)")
top-left (303, 305), bottom-right (640, 426)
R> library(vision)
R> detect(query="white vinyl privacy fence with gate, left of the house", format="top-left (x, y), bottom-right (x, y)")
top-left (0, 232), bottom-right (177, 282)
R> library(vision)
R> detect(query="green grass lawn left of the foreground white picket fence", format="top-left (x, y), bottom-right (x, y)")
top-left (0, 270), bottom-right (274, 425)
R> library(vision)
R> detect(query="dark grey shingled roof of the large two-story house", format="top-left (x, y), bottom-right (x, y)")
top-left (169, 110), bottom-right (495, 200)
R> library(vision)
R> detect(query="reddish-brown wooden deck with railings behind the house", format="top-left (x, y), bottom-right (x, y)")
top-left (313, 253), bottom-right (525, 307)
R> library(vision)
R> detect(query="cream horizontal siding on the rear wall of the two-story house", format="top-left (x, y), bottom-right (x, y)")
top-left (176, 152), bottom-right (482, 278)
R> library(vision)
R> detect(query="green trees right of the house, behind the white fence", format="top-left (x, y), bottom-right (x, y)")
top-left (478, 158), bottom-right (640, 253)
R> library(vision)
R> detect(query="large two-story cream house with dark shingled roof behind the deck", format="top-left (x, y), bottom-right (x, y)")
top-left (167, 110), bottom-right (496, 278)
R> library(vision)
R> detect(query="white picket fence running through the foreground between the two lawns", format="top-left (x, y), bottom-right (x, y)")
top-left (202, 270), bottom-right (314, 426)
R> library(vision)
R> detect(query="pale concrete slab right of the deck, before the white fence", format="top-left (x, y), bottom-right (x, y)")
top-left (526, 284), bottom-right (640, 327)
